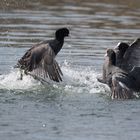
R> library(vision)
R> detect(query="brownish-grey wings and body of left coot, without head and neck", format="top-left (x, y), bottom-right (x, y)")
top-left (18, 43), bottom-right (63, 82)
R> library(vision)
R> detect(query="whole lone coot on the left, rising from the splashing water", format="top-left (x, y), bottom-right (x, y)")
top-left (17, 28), bottom-right (69, 82)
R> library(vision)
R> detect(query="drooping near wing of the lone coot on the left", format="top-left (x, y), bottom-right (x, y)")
top-left (28, 45), bottom-right (63, 82)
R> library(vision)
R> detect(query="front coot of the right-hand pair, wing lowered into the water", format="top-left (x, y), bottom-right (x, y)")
top-left (103, 49), bottom-right (140, 99)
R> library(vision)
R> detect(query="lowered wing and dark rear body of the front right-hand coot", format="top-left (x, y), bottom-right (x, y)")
top-left (108, 67), bottom-right (140, 99)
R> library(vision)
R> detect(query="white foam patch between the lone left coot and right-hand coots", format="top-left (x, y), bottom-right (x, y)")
top-left (62, 62), bottom-right (109, 93)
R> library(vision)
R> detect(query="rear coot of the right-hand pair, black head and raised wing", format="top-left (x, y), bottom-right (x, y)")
top-left (114, 38), bottom-right (140, 72)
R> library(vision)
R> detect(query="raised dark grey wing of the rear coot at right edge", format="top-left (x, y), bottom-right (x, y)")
top-left (123, 38), bottom-right (140, 71)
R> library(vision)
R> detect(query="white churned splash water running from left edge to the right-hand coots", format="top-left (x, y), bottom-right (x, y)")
top-left (0, 64), bottom-right (109, 93)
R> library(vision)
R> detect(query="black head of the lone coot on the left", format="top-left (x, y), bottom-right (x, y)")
top-left (55, 28), bottom-right (69, 40)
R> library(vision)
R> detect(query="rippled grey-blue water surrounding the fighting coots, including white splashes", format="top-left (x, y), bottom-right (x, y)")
top-left (0, 0), bottom-right (140, 140)
